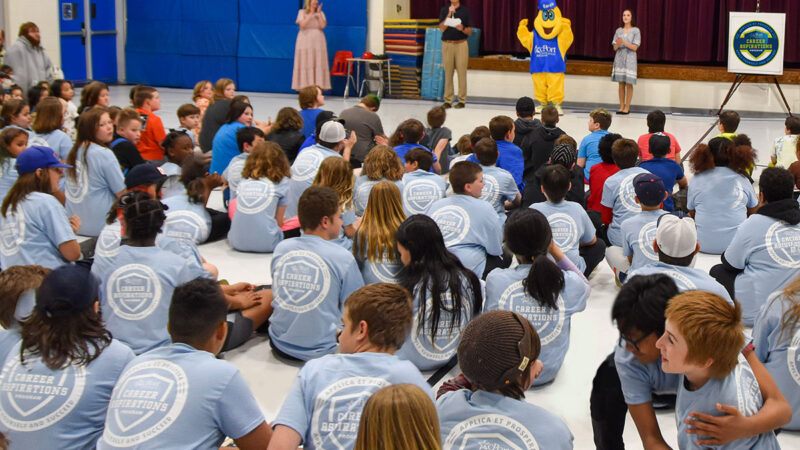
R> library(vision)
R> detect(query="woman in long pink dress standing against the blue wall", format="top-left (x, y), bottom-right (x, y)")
top-left (292, 0), bottom-right (331, 91)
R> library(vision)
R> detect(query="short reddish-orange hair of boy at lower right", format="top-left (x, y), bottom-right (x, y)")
top-left (664, 291), bottom-right (744, 378)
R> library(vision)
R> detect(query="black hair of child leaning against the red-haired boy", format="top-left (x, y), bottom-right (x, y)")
top-left (611, 273), bottom-right (680, 336)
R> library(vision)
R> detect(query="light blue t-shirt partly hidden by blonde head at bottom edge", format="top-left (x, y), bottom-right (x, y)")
top-left (272, 352), bottom-right (433, 450)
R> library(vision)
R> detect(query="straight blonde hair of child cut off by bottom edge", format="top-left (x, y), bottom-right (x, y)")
top-left (353, 384), bottom-right (442, 450)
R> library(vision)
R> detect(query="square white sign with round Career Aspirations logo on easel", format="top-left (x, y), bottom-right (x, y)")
top-left (728, 12), bottom-right (786, 75)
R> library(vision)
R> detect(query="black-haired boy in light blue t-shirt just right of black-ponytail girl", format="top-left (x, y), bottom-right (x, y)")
top-left (530, 164), bottom-right (606, 277)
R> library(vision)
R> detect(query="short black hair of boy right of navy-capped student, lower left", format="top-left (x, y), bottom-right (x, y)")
top-left (169, 277), bottom-right (228, 346)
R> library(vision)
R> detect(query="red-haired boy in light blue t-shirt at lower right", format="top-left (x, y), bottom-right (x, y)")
top-left (656, 291), bottom-right (789, 449)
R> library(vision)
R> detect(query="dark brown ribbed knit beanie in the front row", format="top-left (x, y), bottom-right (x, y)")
top-left (458, 311), bottom-right (541, 390)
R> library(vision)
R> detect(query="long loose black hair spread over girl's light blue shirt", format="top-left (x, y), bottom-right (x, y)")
top-left (397, 214), bottom-right (483, 339)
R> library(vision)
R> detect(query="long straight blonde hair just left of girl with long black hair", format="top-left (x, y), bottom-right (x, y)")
top-left (353, 181), bottom-right (406, 262)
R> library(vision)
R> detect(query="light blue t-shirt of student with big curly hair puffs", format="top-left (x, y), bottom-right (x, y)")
top-left (686, 167), bottom-right (758, 255)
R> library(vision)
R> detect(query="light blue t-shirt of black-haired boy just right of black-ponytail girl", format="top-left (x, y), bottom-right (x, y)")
top-left (530, 200), bottom-right (595, 272)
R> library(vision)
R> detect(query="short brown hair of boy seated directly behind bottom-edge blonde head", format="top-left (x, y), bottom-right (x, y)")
top-left (344, 283), bottom-right (413, 350)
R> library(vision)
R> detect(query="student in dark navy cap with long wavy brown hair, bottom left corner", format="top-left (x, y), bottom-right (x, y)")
top-left (0, 265), bottom-right (133, 448)
